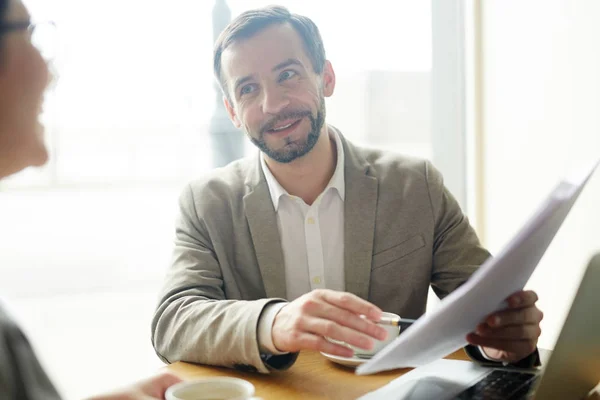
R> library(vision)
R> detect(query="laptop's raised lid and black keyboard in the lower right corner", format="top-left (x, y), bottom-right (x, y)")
top-left (454, 253), bottom-right (600, 400)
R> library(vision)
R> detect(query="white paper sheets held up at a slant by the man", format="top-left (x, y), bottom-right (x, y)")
top-left (356, 161), bottom-right (598, 375)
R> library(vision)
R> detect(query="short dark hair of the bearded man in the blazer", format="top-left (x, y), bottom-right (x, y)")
top-left (214, 6), bottom-right (325, 97)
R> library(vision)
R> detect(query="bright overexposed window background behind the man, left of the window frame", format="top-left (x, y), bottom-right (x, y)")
top-left (0, 0), bottom-right (431, 399)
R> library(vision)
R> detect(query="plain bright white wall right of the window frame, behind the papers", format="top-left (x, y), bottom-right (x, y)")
top-left (482, 0), bottom-right (600, 348)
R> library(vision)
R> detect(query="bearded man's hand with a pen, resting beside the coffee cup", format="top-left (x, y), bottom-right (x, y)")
top-left (271, 289), bottom-right (387, 357)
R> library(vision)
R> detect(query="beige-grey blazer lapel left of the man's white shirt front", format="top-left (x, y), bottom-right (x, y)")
top-left (244, 156), bottom-right (287, 299)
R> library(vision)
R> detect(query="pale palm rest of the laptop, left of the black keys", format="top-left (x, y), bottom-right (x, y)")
top-left (359, 360), bottom-right (490, 400)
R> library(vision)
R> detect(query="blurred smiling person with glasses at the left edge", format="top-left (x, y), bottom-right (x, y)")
top-left (0, 0), bottom-right (180, 400)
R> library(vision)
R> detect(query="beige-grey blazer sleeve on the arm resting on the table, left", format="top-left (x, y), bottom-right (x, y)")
top-left (152, 186), bottom-right (298, 373)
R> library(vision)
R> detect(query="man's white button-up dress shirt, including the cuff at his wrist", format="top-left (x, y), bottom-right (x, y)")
top-left (258, 128), bottom-right (345, 354)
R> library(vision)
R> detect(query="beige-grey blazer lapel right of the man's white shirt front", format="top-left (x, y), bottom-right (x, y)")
top-left (342, 137), bottom-right (378, 299)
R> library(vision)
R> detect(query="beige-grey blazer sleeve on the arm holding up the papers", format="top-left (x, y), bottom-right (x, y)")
top-left (425, 162), bottom-right (490, 298)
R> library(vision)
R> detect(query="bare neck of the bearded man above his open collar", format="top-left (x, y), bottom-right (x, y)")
top-left (265, 125), bottom-right (337, 205)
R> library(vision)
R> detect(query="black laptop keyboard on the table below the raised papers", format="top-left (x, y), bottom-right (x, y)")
top-left (454, 369), bottom-right (538, 400)
